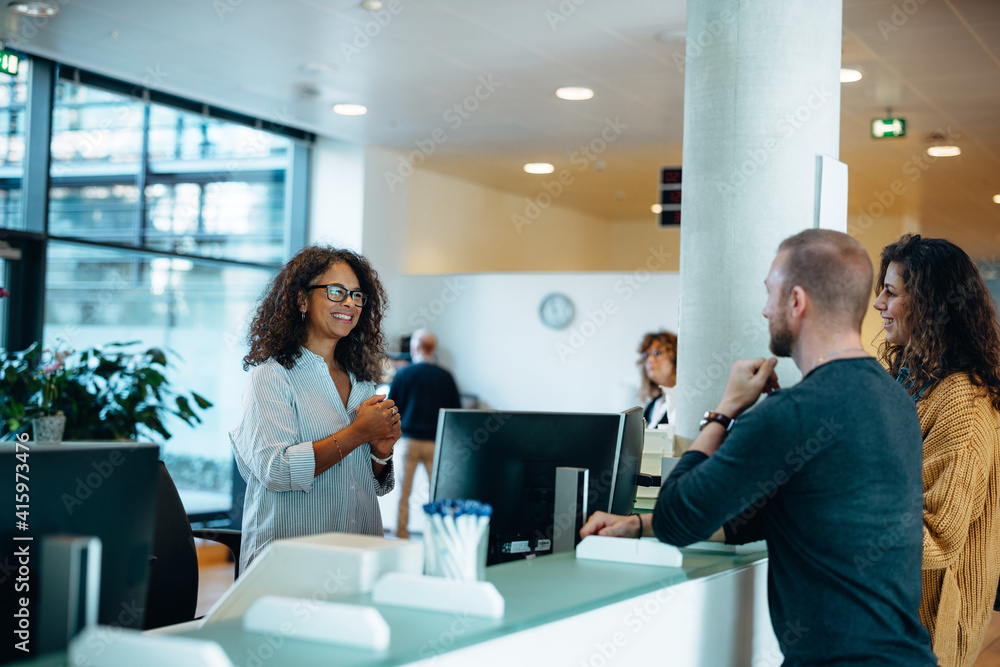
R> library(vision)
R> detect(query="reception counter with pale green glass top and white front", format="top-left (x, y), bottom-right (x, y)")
top-left (184, 550), bottom-right (781, 667)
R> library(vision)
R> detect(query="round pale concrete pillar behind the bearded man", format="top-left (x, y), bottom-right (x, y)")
top-left (677, 0), bottom-right (842, 438)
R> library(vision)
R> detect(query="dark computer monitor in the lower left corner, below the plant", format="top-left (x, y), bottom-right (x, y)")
top-left (0, 442), bottom-right (159, 662)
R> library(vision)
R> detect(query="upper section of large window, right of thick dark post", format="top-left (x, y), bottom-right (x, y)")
top-left (49, 81), bottom-right (292, 263)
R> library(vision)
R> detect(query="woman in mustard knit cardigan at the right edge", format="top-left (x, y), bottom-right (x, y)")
top-left (873, 234), bottom-right (1000, 667)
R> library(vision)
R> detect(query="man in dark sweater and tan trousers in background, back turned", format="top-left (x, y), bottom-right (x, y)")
top-left (389, 329), bottom-right (462, 539)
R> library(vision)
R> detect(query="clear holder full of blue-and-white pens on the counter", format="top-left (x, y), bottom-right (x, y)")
top-left (424, 500), bottom-right (493, 581)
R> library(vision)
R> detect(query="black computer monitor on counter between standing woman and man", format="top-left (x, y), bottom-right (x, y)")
top-left (431, 407), bottom-right (643, 565)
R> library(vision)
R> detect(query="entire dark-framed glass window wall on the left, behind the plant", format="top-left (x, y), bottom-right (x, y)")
top-left (0, 59), bottom-right (312, 513)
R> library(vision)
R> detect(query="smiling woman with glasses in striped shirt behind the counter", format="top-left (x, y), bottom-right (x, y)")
top-left (230, 246), bottom-right (400, 571)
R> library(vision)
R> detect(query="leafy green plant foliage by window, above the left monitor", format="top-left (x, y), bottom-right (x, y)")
top-left (0, 341), bottom-right (212, 440)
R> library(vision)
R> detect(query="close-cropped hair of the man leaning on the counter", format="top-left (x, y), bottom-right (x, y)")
top-left (778, 229), bottom-right (874, 331)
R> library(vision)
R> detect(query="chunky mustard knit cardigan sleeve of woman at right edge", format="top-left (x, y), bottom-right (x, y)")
top-left (917, 374), bottom-right (992, 570)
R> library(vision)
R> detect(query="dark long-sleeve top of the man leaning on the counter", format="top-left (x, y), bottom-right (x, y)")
top-left (653, 358), bottom-right (936, 667)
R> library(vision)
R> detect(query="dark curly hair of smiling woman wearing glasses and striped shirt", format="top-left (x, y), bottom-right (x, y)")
top-left (243, 246), bottom-right (388, 382)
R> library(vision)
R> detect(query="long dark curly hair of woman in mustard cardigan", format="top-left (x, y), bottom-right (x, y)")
top-left (875, 234), bottom-right (1000, 410)
